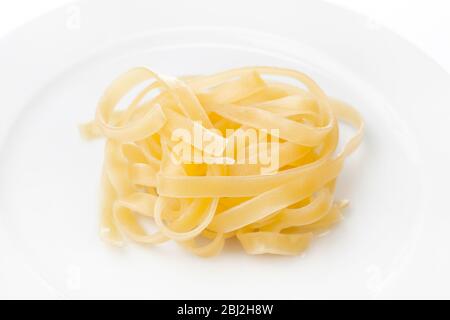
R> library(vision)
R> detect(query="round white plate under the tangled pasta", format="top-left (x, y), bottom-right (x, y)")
top-left (0, 0), bottom-right (450, 299)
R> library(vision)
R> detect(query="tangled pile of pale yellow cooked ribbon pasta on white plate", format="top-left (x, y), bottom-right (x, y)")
top-left (80, 67), bottom-right (364, 257)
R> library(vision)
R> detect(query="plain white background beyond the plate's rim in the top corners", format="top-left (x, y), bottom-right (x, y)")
top-left (0, 0), bottom-right (450, 72)
